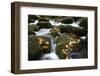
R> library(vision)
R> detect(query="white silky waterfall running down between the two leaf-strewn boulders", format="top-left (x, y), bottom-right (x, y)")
top-left (36, 29), bottom-right (59, 60)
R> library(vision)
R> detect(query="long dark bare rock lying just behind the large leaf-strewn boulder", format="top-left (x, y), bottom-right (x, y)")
top-left (59, 25), bottom-right (87, 36)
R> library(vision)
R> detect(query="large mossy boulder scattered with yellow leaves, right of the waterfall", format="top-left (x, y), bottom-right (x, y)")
top-left (56, 33), bottom-right (80, 59)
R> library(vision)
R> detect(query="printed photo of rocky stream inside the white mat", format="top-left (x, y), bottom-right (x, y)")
top-left (28, 15), bottom-right (88, 60)
